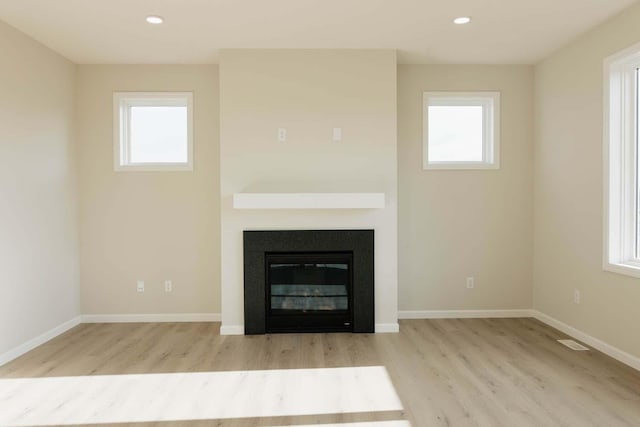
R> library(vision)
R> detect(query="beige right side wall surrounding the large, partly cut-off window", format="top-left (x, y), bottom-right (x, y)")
top-left (534, 1), bottom-right (640, 357)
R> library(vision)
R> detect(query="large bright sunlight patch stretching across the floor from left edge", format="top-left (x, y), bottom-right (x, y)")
top-left (0, 366), bottom-right (404, 427)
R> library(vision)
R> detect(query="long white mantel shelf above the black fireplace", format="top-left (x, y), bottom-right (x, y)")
top-left (233, 193), bottom-right (384, 209)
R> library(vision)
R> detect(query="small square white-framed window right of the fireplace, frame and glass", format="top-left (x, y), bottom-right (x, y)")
top-left (422, 92), bottom-right (500, 169)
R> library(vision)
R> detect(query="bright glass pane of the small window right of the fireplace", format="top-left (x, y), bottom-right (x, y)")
top-left (427, 105), bottom-right (483, 162)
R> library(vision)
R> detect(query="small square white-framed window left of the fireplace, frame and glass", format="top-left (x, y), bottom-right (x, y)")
top-left (113, 92), bottom-right (193, 171)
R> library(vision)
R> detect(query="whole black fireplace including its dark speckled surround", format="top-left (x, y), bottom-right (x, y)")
top-left (244, 230), bottom-right (374, 334)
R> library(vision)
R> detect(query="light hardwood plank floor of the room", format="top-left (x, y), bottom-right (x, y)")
top-left (0, 319), bottom-right (640, 427)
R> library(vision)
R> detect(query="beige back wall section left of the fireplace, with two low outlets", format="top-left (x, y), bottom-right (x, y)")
top-left (77, 65), bottom-right (220, 315)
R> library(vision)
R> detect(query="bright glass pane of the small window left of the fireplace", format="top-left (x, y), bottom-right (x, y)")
top-left (130, 106), bottom-right (188, 163)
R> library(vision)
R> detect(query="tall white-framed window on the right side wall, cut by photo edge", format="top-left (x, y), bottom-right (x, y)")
top-left (604, 45), bottom-right (640, 277)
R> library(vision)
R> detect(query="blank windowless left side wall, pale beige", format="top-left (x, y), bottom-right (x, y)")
top-left (0, 22), bottom-right (80, 355)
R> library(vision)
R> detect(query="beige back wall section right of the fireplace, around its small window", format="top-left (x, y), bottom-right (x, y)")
top-left (398, 65), bottom-right (533, 311)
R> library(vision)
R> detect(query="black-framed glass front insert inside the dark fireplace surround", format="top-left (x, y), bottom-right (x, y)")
top-left (266, 253), bottom-right (353, 332)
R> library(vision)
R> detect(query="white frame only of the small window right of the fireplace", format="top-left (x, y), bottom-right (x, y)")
top-left (422, 92), bottom-right (500, 169)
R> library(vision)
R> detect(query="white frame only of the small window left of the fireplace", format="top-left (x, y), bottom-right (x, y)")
top-left (113, 92), bottom-right (193, 171)
